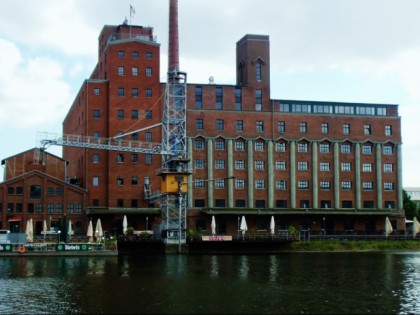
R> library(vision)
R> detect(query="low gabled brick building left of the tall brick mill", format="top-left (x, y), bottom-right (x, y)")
top-left (0, 148), bottom-right (87, 235)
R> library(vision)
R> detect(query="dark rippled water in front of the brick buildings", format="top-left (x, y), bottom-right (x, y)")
top-left (0, 252), bottom-right (420, 314)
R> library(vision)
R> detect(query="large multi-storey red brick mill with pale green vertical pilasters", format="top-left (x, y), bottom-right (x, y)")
top-left (59, 24), bottom-right (405, 234)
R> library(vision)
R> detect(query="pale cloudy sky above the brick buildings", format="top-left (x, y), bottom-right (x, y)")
top-left (0, 0), bottom-right (420, 187)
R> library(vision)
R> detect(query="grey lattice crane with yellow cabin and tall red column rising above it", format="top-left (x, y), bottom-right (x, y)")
top-left (40, 0), bottom-right (192, 252)
